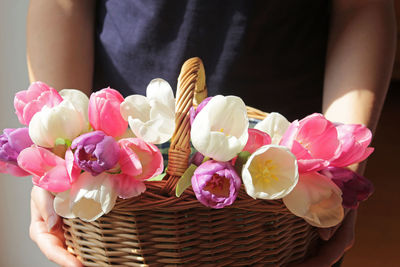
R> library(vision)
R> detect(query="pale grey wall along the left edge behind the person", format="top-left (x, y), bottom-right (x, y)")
top-left (0, 0), bottom-right (56, 267)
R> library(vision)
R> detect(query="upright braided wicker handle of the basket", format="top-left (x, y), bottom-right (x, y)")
top-left (162, 57), bottom-right (207, 195)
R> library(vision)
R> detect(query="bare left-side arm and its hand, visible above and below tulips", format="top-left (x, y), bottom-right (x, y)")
top-left (27, 0), bottom-right (95, 267)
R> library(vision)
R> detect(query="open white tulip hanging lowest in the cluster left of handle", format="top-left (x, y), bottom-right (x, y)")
top-left (54, 172), bottom-right (118, 222)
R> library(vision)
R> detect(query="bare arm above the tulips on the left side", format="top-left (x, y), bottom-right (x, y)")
top-left (27, 0), bottom-right (95, 94)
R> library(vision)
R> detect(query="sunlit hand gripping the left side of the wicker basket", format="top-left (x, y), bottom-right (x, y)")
top-left (29, 186), bottom-right (83, 267)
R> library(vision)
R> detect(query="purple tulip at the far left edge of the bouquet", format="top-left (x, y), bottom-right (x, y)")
top-left (0, 128), bottom-right (33, 165)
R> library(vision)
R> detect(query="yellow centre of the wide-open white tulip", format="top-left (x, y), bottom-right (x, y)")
top-left (250, 159), bottom-right (279, 186)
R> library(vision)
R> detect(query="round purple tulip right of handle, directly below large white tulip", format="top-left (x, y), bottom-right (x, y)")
top-left (192, 160), bottom-right (242, 209)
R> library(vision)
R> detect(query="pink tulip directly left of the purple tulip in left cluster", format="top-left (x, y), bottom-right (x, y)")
top-left (18, 146), bottom-right (80, 192)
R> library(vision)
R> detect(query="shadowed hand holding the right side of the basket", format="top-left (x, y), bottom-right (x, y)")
top-left (296, 210), bottom-right (357, 267)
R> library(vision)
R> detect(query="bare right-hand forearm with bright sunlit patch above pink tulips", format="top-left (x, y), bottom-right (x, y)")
top-left (323, 0), bottom-right (396, 131)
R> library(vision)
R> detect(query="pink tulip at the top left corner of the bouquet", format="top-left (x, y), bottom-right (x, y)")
top-left (14, 82), bottom-right (63, 125)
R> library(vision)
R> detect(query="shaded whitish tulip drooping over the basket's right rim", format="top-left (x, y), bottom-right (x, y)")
top-left (283, 172), bottom-right (344, 228)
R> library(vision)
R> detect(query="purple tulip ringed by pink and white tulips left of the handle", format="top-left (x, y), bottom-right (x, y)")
top-left (71, 131), bottom-right (120, 176)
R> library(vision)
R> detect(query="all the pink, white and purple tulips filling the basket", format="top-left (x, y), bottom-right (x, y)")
top-left (0, 79), bottom-right (373, 227)
